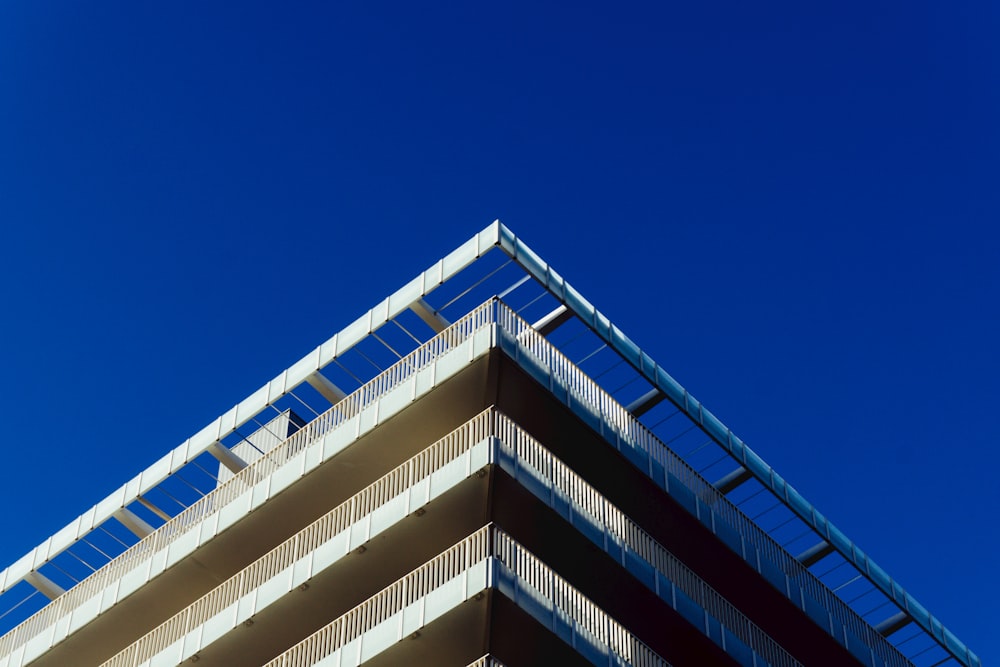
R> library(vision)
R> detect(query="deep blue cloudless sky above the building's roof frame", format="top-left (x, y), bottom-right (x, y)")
top-left (0, 0), bottom-right (1000, 664)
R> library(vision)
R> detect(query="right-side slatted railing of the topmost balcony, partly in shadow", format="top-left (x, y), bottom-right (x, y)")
top-left (497, 305), bottom-right (912, 667)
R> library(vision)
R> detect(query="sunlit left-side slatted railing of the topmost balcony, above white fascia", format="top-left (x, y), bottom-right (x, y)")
top-left (0, 300), bottom-right (496, 656)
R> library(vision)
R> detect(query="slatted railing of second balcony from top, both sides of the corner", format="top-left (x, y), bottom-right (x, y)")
top-left (102, 408), bottom-right (799, 667)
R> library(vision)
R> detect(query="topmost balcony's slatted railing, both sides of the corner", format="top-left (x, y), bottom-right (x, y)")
top-left (0, 299), bottom-right (910, 667)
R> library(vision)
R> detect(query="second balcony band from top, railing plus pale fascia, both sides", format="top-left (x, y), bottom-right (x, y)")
top-left (103, 408), bottom-right (799, 667)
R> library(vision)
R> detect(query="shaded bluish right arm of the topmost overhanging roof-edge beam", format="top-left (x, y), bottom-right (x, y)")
top-left (487, 221), bottom-right (982, 667)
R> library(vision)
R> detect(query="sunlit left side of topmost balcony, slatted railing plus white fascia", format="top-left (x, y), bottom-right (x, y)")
top-left (0, 300), bottom-right (496, 667)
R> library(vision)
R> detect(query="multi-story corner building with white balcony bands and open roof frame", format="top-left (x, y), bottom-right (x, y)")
top-left (0, 222), bottom-right (981, 667)
